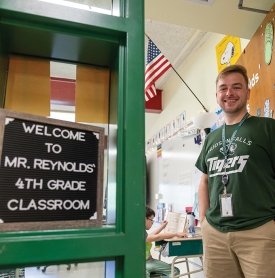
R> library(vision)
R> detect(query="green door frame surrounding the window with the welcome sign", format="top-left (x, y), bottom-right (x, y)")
top-left (0, 0), bottom-right (145, 278)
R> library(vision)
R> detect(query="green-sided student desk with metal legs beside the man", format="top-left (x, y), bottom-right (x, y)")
top-left (156, 236), bottom-right (203, 278)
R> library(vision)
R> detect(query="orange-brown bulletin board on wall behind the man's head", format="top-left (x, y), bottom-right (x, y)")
top-left (237, 4), bottom-right (275, 118)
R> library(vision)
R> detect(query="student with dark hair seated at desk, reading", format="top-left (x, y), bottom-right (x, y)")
top-left (145, 207), bottom-right (186, 278)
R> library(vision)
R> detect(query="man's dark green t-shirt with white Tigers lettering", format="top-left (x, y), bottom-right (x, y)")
top-left (196, 117), bottom-right (275, 232)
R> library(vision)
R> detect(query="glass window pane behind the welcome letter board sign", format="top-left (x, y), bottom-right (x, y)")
top-left (5, 56), bottom-right (117, 228)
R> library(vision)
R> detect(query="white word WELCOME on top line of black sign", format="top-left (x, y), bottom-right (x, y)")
top-left (22, 122), bottom-right (86, 142)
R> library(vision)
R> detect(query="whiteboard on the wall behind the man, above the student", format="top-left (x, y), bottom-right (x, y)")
top-left (158, 136), bottom-right (201, 212)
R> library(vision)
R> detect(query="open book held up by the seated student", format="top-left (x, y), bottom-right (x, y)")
top-left (163, 211), bottom-right (187, 233)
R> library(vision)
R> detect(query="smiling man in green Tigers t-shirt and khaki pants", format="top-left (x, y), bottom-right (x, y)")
top-left (196, 65), bottom-right (275, 278)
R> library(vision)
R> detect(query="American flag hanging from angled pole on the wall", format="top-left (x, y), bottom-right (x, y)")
top-left (145, 39), bottom-right (172, 101)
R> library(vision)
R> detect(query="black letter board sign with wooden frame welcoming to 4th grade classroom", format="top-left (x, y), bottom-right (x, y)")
top-left (0, 109), bottom-right (104, 230)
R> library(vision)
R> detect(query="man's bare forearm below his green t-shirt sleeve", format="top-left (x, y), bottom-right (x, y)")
top-left (198, 174), bottom-right (209, 221)
